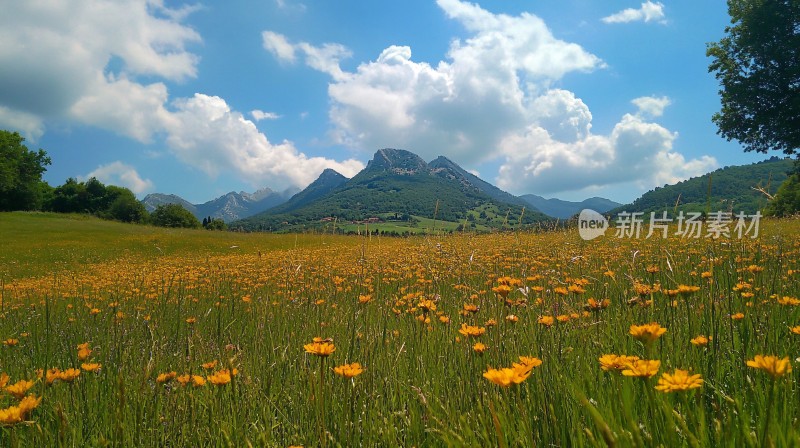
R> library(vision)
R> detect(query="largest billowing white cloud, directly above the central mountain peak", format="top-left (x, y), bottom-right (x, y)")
top-left (265, 0), bottom-right (604, 163)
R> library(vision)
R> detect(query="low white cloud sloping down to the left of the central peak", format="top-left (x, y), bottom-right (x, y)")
top-left (167, 93), bottom-right (364, 189)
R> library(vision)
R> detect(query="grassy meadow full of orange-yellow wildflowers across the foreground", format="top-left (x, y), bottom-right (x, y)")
top-left (0, 213), bottom-right (800, 447)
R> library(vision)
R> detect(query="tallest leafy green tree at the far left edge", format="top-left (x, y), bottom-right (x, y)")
top-left (0, 131), bottom-right (51, 211)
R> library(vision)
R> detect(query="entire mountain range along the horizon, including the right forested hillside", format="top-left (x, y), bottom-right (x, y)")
top-left (142, 148), bottom-right (793, 231)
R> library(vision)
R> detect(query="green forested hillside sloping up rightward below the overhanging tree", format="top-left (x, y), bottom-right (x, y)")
top-left (608, 157), bottom-right (794, 215)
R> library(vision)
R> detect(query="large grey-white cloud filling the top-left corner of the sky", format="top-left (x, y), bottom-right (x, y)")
top-left (0, 0), bottom-right (200, 135)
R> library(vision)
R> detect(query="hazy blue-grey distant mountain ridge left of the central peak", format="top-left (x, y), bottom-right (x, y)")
top-left (142, 188), bottom-right (293, 222)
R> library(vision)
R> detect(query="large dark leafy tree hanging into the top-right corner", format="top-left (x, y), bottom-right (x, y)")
top-left (706, 0), bottom-right (800, 154)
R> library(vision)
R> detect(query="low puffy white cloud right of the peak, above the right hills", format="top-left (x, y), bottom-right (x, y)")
top-left (497, 110), bottom-right (717, 194)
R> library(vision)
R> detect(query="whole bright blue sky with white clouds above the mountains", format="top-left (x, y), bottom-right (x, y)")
top-left (0, 0), bottom-right (767, 203)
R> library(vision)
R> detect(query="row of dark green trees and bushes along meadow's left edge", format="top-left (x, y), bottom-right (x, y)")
top-left (0, 130), bottom-right (226, 230)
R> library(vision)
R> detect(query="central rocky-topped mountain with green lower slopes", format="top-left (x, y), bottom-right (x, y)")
top-left (232, 148), bottom-right (548, 231)
